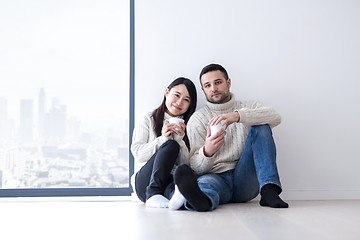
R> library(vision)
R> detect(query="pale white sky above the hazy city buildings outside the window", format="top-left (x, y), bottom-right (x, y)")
top-left (0, 0), bottom-right (129, 133)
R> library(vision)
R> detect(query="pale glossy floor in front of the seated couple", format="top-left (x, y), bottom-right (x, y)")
top-left (0, 198), bottom-right (360, 240)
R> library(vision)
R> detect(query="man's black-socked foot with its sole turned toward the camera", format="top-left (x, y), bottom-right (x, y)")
top-left (174, 164), bottom-right (211, 212)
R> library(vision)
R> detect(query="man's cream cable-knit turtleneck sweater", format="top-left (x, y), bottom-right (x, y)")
top-left (186, 94), bottom-right (281, 174)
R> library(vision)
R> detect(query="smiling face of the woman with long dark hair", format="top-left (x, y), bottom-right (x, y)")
top-left (165, 84), bottom-right (191, 117)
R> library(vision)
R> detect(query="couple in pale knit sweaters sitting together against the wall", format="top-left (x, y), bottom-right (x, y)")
top-left (131, 64), bottom-right (288, 212)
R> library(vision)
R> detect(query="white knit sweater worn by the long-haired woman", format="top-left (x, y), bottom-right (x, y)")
top-left (131, 112), bottom-right (189, 182)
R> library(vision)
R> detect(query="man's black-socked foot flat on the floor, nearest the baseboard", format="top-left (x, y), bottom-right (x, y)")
top-left (260, 184), bottom-right (289, 208)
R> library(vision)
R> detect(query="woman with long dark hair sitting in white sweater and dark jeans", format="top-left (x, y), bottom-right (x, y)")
top-left (131, 77), bottom-right (197, 208)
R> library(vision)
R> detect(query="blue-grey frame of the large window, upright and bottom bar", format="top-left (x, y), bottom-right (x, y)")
top-left (0, 0), bottom-right (135, 198)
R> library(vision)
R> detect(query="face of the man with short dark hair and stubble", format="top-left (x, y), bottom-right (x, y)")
top-left (201, 70), bottom-right (231, 103)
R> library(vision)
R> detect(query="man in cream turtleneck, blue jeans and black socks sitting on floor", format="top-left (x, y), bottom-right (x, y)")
top-left (172, 64), bottom-right (288, 211)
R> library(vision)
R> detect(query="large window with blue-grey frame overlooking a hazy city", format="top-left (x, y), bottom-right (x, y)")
top-left (0, 0), bottom-right (134, 196)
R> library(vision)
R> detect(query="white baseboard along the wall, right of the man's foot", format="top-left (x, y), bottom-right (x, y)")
top-left (281, 190), bottom-right (360, 200)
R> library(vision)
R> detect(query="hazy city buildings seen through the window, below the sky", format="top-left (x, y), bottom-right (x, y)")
top-left (0, 88), bottom-right (129, 188)
